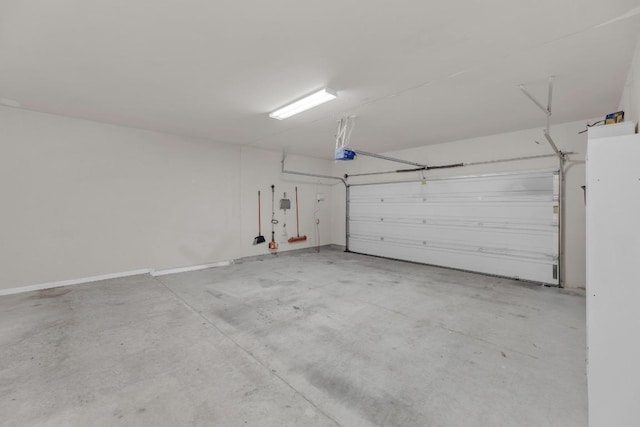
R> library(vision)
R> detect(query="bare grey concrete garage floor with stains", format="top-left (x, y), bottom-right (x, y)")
top-left (0, 249), bottom-right (587, 427)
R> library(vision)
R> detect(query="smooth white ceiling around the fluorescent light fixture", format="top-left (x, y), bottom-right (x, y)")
top-left (0, 0), bottom-right (640, 158)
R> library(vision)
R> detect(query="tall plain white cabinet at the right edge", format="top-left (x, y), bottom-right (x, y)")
top-left (586, 130), bottom-right (640, 427)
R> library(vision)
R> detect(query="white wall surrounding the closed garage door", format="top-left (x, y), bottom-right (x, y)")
top-left (332, 118), bottom-right (587, 287)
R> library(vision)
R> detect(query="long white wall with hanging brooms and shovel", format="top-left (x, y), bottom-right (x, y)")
top-left (0, 107), bottom-right (331, 290)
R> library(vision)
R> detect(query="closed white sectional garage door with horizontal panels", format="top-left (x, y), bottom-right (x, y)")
top-left (347, 171), bottom-right (559, 285)
